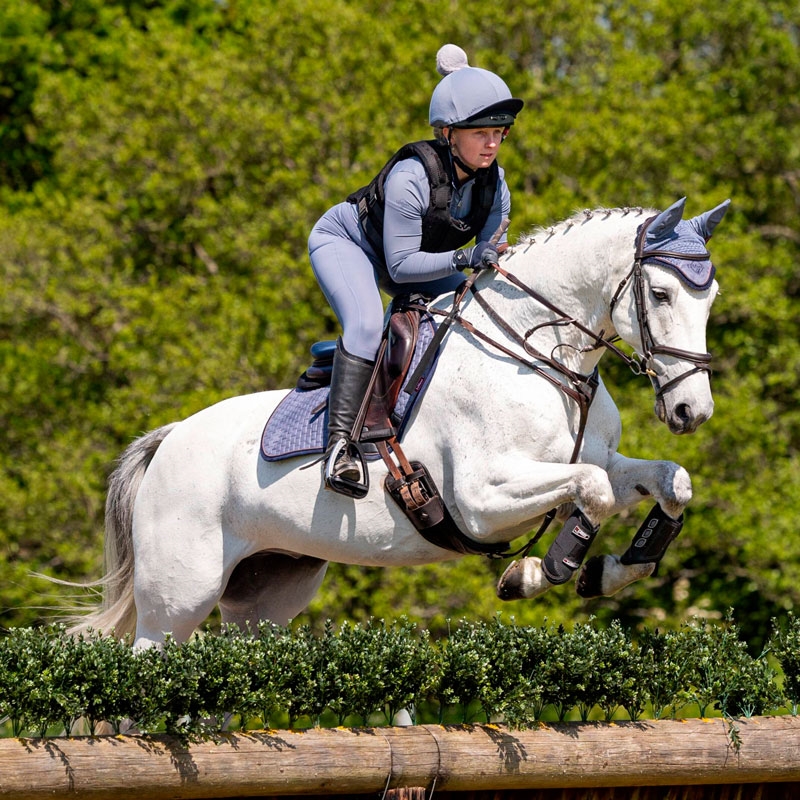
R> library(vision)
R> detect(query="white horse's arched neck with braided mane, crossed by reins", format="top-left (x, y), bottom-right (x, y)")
top-left (456, 215), bottom-right (637, 374)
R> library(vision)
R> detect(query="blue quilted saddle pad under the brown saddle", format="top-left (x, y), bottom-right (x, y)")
top-left (261, 313), bottom-right (438, 461)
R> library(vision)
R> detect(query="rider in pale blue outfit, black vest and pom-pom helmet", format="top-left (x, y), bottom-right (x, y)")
top-left (308, 44), bottom-right (523, 489)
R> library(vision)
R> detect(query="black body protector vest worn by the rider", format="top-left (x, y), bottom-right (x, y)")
top-left (347, 140), bottom-right (499, 260)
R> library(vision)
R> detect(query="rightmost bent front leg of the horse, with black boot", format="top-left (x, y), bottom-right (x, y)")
top-left (576, 454), bottom-right (692, 598)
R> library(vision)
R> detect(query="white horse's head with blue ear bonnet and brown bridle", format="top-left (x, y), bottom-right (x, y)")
top-left (611, 198), bottom-right (730, 433)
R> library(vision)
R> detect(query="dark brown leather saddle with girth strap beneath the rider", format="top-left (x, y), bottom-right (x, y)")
top-left (262, 296), bottom-right (508, 557)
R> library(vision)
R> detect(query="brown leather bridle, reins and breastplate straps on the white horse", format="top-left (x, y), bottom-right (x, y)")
top-left (412, 217), bottom-right (711, 558)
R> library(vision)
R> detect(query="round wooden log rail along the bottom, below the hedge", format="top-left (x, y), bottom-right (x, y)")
top-left (0, 716), bottom-right (800, 800)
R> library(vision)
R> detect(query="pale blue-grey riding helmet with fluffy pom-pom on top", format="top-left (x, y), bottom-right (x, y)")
top-left (428, 44), bottom-right (523, 128)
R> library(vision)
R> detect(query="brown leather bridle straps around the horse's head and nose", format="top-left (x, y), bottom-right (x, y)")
top-left (609, 217), bottom-right (711, 399)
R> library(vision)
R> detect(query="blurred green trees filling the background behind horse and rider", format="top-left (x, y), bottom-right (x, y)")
top-left (0, 0), bottom-right (800, 644)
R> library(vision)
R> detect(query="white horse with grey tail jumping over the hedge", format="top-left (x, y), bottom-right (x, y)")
top-left (78, 198), bottom-right (727, 647)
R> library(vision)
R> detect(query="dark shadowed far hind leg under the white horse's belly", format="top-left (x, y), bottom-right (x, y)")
top-left (219, 552), bottom-right (328, 632)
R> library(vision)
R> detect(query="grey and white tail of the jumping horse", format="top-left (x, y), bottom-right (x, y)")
top-left (70, 422), bottom-right (178, 637)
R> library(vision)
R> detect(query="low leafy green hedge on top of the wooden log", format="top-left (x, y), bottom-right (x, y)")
top-left (0, 613), bottom-right (800, 736)
